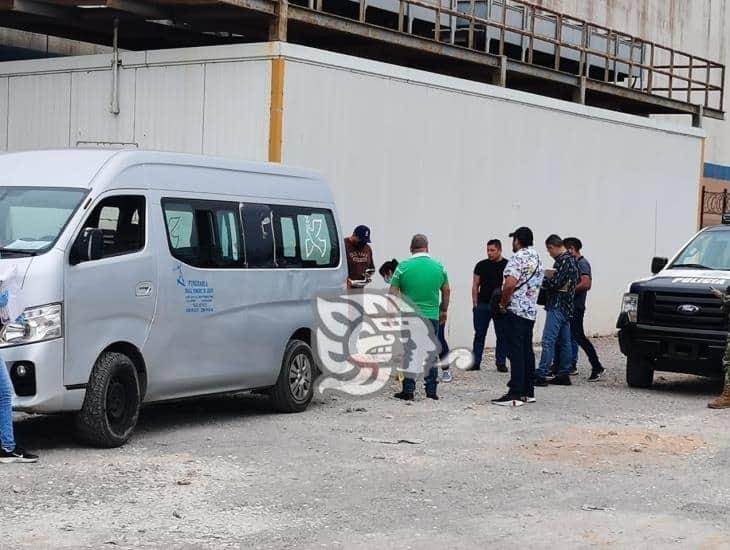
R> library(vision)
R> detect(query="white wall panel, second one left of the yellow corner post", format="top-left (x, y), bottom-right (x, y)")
top-left (135, 65), bottom-right (204, 153)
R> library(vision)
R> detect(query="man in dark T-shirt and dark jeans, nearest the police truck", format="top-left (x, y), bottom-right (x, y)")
top-left (563, 237), bottom-right (606, 382)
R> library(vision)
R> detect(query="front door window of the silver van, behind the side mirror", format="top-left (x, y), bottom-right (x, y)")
top-left (81, 195), bottom-right (145, 258)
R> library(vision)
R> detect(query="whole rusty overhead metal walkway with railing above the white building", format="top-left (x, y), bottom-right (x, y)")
top-left (0, 0), bottom-right (725, 126)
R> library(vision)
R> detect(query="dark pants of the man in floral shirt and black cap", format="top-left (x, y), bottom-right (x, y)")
top-left (504, 311), bottom-right (535, 397)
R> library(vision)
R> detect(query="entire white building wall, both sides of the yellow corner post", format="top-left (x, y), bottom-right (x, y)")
top-left (0, 44), bottom-right (702, 345)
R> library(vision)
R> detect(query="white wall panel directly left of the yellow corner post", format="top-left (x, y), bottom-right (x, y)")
top-left (203, 61), bottom-right (271, 160)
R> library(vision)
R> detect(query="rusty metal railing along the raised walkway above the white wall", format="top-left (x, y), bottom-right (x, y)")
top-left (289, 0), bottom-right (725, 111)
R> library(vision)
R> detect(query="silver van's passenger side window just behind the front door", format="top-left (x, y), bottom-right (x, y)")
top-left (162, 199), bottom-right (244, 268)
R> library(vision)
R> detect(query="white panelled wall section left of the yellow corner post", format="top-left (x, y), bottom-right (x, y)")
top-left (0, 45), bottom-right (271, 160)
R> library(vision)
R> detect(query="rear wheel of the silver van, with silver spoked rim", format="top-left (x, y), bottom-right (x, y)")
top-left (269, 340), bottom-right (315, 413)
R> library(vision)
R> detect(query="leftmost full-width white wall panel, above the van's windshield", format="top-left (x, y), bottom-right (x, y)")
top-left (7, 73), bottom-right (71, 151)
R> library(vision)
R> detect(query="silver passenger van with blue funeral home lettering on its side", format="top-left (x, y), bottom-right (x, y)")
top-left (0, 149), bottom-right (347, 447)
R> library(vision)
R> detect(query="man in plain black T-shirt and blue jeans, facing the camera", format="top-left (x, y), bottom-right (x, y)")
top-left (471, 239), bottom-right (507, 372)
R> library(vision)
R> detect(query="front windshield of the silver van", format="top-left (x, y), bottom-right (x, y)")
top-left (0, 187), bottom-right (87, 256)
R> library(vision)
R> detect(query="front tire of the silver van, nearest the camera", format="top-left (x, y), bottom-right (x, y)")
top-left (74, 352), bottom-right (142, 448)
